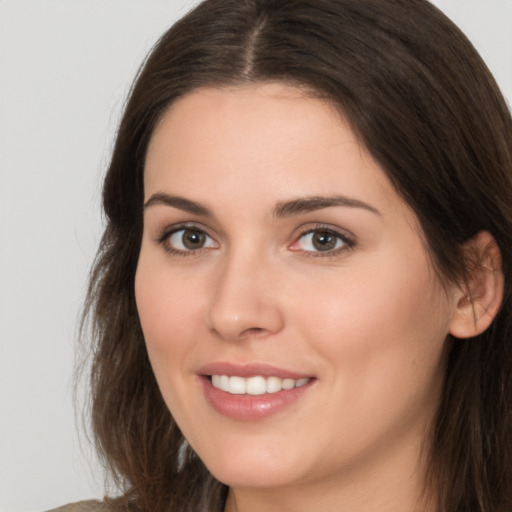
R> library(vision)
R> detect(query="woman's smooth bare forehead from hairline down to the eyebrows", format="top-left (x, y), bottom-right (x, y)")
top-left (145, 83), bottom-right (389, 200)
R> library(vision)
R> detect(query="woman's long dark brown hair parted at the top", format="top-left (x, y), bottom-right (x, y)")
top-left (81, 0), bottom-right (512, 512)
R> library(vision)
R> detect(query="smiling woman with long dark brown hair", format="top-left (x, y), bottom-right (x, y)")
top-left (55, 0), bottom-right (512, 512)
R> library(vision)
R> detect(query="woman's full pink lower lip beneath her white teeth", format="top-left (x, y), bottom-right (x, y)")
top-left (201, 377), bottom-right (314, 421)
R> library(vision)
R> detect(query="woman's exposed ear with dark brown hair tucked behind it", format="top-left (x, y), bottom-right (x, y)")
top-left (450, 231), bottom-right (504, 338)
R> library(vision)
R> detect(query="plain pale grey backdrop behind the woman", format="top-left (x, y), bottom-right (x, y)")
top-left (0, 0), bottom-right (512, 512)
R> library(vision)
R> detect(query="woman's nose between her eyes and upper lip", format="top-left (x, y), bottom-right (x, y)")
top-left (208, 247), bottom-right (284, 341)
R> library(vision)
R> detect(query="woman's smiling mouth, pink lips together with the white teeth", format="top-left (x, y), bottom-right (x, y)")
top-left (198, 363), bottom-right (316, 421)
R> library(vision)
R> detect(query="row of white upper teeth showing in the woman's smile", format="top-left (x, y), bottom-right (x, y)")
top-left (211, 375), bottom-right (311, 395)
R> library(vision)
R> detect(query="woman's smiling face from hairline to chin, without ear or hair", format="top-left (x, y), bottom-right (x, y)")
top-left (135, 84), bottom-right (454, 496)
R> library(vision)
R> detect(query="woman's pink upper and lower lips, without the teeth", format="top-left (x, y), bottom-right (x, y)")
top-left (198, 362), bottom-right (316, 421)
